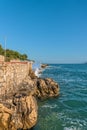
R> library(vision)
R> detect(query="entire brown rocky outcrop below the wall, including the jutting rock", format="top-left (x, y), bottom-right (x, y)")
top-left (0, 73), bottom-right (59, 130)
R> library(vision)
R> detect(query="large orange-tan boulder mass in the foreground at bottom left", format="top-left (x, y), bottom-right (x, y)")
top-left (0, 93), bottom-right (37, 130)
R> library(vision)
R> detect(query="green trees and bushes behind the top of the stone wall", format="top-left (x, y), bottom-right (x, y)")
top-left (0, 45), bottom-right (28, 61)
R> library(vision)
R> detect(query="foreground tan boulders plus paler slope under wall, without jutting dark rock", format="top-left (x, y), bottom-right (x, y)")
top-left (0, 76), bottom-right (38, 130)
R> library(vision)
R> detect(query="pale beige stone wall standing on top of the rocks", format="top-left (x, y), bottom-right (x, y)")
top-left (0, 62), bottom-right (32, 94)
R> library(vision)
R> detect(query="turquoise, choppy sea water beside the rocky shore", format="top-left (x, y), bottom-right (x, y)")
top-left (34, 64), bottom-right (87, 130)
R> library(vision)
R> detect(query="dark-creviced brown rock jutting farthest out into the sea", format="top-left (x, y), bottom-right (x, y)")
top-left (35, 78), bottom-right (59, 99)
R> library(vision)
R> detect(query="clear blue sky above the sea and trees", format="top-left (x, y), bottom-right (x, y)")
top-left (0, 0), bottom-right (87, 63)
